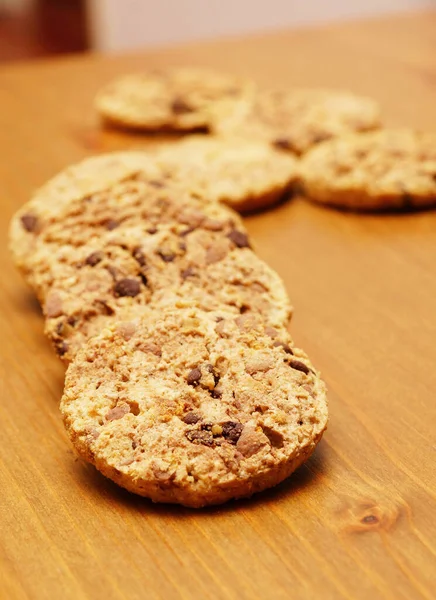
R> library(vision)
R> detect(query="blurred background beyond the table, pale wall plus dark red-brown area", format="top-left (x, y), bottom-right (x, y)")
top-left (0, 0), bottom-right (436, 62)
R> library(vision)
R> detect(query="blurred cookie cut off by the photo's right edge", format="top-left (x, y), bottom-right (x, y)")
top-left (301, 130), bottom-right (436, 210)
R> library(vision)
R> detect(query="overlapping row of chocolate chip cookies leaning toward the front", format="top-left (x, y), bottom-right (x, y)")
top-left (11, 152), bottom-right (327, 507)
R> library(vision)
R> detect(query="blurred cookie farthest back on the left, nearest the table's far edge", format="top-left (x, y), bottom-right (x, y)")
top-left (95, 68), bottom-right (254, 131)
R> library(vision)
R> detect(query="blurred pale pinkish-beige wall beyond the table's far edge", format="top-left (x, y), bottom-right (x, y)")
top-left (88, 0), bottom-right (436, 51)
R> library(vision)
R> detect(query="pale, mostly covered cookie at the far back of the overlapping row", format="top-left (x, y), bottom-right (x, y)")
top-left (9, 152), bottom-right (165, 288)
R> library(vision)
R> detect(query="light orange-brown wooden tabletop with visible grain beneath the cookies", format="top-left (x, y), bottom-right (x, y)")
top-left (0, 13), bottom-right (436, 600)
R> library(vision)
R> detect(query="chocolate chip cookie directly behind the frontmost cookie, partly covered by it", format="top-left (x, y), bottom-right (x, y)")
top-left (42, 219), bottom-right (292, 362)
